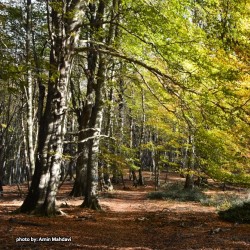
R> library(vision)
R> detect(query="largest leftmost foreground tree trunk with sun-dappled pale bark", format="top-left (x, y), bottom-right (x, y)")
top-left (19, 0), bottom-right (82, 216)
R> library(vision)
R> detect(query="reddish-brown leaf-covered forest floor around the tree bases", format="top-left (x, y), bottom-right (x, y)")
top-left (0, 173), bottom-right (250, 250)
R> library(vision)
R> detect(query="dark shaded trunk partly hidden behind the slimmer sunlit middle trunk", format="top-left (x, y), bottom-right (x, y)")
top-left (71, 1), bottom-right (105, 199)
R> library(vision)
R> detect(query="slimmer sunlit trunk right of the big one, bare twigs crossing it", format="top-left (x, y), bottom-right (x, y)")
top-left (82, 1), bottom-right (107, 210)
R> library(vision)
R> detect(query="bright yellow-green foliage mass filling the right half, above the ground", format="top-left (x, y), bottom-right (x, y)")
top-left (111, 1), bottom-right (250, 189)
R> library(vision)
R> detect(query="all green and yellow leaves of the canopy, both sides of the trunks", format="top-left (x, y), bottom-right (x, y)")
top-left (0, 0), bottom-right (250, 192)
